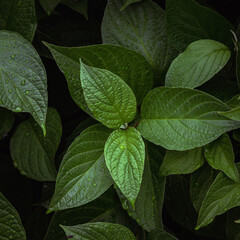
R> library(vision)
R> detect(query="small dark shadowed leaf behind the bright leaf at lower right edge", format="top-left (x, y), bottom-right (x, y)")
top-left (190, 164), bottom-right (218, 212)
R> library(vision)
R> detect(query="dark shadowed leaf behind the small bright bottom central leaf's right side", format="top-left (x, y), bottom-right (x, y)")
top-left (118, 147), bottom-right (165, 232)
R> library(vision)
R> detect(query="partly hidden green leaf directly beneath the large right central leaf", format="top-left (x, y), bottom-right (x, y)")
top-left (159, 148), bottom-right (205, 176)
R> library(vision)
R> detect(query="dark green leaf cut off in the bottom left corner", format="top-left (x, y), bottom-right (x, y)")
top-left (0, 193), bottom-right (26, 240)
